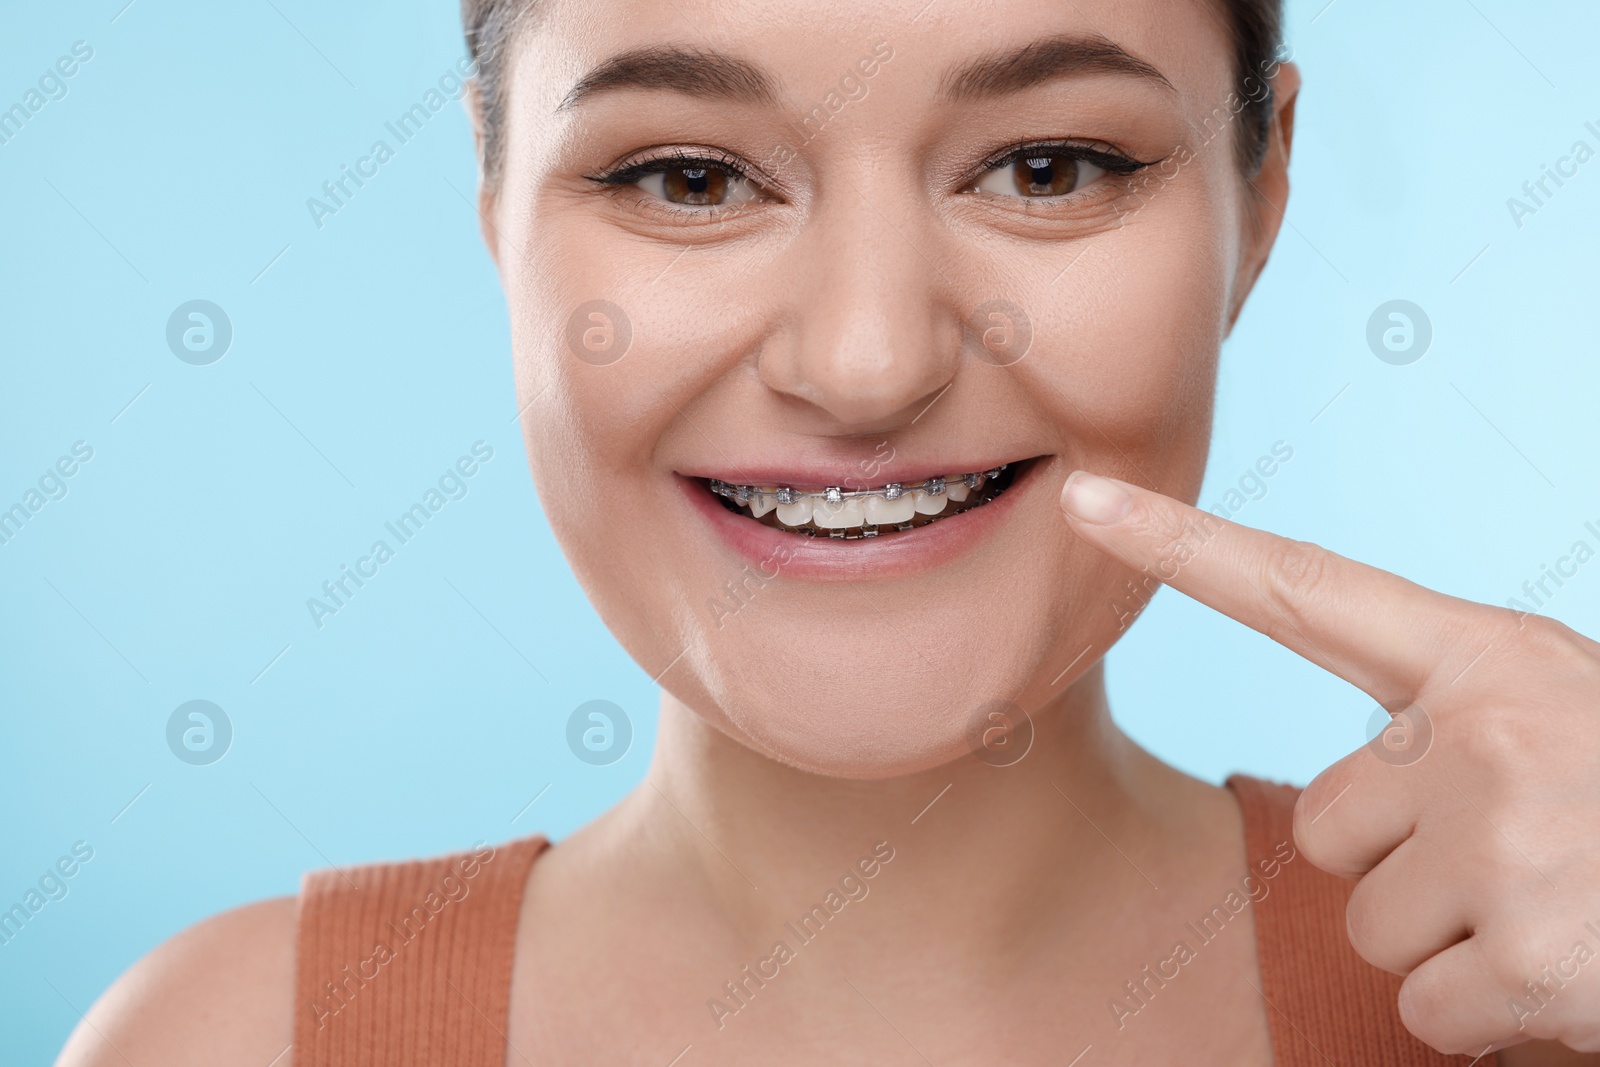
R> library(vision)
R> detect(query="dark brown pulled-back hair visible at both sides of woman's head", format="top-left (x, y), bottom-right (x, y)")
top-left (461, 0), bottom-right (1283, 189)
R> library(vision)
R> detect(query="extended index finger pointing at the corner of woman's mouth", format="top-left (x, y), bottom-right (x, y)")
top-left (1061, 470), bottom-right (1486, 707)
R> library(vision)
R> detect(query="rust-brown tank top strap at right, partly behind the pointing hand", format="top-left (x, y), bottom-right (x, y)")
top-left (1227, 774), bottom-right (1496, 1067)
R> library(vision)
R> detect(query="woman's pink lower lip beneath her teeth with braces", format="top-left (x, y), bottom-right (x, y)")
top-left (675, 458), bottom-right (1045, 582)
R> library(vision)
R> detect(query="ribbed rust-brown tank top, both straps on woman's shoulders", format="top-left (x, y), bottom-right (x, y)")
top-left (293, 774), bottom-right (1496, 1067)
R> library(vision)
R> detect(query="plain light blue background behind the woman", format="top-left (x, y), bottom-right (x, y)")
top-left (0, 0), bottom-right (1600, 1064)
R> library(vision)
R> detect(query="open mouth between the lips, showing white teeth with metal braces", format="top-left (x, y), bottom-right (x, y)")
top-left (704, 459), bottom-right (1034, 541)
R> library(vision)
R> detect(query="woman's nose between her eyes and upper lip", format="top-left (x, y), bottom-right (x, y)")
top-left (760, 192), bottom-right (960, 427)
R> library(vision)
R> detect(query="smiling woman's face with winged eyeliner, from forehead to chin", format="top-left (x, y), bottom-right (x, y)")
top-left (486, 0), bottom-right (1275, 777)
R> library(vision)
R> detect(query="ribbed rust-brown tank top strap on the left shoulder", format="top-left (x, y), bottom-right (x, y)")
top-left (293, 835), bottom-right (549, 1067)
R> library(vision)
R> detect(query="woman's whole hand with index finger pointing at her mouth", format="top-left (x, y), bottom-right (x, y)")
top-left (1062, 472), bottom-right (1600, 1056)
